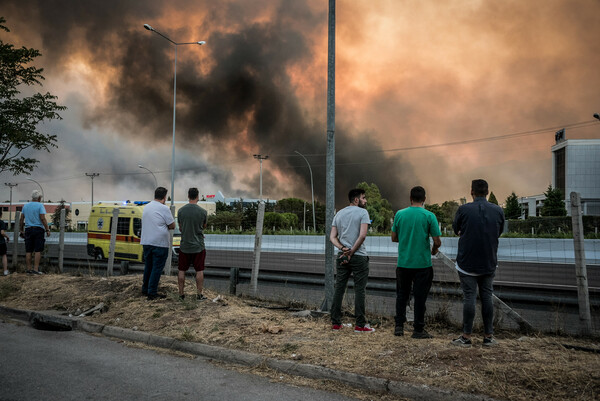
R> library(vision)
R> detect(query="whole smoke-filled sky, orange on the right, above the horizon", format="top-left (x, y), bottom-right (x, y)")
top-left (0, 0), bottom-right (600, 209)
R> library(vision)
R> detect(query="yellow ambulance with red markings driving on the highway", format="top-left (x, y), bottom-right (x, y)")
top-left (87, 202), bottom-right (181, 263)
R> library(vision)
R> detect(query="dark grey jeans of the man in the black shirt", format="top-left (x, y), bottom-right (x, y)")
top-left (458, 272), bottom-right (495, 335)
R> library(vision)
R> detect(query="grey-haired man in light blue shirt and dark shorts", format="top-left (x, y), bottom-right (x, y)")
top-left (20, 189), bottom-right (50, 274)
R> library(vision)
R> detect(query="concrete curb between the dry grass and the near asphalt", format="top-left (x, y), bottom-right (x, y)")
top-left (0, 305), bottom-right (495, 401)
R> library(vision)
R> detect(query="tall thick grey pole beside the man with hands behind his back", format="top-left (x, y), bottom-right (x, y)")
top-left (321, 0), bottom-right (335, 311)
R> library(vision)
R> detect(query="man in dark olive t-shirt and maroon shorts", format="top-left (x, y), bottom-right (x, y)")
top-left (177, 188), bottom-right (207, 301)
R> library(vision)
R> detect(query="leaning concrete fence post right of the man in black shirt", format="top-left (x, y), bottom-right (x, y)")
top-left (571, 192), bottom-right (592, 334)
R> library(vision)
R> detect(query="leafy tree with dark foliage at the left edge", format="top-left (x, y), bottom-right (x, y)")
top-left (0, 17), bottom-right (66, 175)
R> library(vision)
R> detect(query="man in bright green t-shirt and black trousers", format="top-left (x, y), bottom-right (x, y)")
top-left (392, 187), bottom-right (442, 338)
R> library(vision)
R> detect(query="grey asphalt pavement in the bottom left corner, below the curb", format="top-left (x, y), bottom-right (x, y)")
top-left (0, 321), bottom-right (353, 401)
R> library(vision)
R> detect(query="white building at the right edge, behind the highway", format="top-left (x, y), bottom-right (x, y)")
top-left (552, 137), bottom-right (600, 216)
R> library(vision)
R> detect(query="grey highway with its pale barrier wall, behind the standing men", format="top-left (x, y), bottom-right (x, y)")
top-left (9, 233), bottom-right (600, 291)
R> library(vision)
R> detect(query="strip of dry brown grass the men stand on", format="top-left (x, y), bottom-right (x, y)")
top-left (0, 274), bottom-right (600, 400)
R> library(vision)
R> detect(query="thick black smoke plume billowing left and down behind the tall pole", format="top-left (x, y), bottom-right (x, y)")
top-left (0, 0), bottom-right (412, 206)
